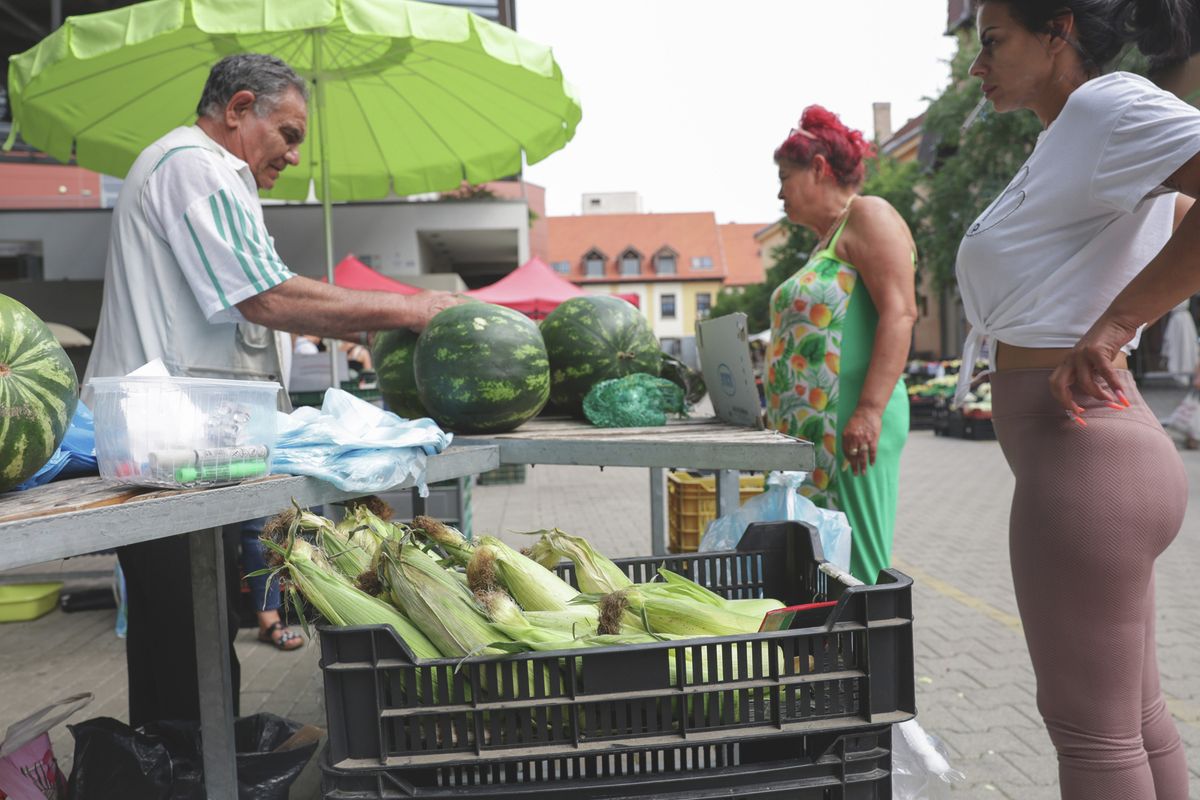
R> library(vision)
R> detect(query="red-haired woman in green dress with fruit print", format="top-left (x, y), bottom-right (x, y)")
top-left (766, 106), bottom-right (917, 583)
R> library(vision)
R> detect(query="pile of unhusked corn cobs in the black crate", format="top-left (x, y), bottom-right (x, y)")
top-left (263, 504), bottom-right (784, 668)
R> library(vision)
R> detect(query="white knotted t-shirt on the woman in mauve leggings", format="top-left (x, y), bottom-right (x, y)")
top-left (955, 72), bottom-right (1200, 402)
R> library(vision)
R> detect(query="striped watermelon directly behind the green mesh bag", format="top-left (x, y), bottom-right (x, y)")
top-left (541, 295), bottom-right (662, 416)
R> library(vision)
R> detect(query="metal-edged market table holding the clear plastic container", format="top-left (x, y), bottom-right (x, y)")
top-left (0, 447), bottom-right (499, 800)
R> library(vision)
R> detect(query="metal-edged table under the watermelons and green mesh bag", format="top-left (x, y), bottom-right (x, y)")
top-left (455, 416), bottom-right (816, 555)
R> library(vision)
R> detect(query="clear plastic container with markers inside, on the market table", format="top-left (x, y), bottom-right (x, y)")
top-left (88, 377), bottom-right (281, 488)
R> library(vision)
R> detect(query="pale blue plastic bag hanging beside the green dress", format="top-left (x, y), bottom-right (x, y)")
top-left (700, 473), bottom-right (850, 572)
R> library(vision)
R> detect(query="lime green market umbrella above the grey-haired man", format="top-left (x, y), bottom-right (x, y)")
top-left (5, 0), bottom-right (581, 369)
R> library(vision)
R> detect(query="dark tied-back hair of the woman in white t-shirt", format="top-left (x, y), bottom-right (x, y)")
top-left (984, 0), bottom-right (1196, 74)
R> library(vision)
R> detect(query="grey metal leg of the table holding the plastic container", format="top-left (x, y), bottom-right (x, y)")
top-left (188, 528), bottom-right (238, 800)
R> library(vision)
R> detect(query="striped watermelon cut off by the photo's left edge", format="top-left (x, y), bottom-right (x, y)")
top-left (0, 295), bottom-right (79, 492)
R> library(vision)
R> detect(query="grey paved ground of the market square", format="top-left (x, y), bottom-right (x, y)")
top-left (0, 392), bottom-right (1200, 800)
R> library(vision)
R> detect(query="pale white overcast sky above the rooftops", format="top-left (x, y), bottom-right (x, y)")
top-left (517, 0), bottom-right (954, 222)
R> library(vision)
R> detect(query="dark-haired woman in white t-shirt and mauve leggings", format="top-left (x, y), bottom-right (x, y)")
top-left (958, 0), bottom-right (1200, 800)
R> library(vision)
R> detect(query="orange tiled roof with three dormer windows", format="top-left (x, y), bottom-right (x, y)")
top-left (547, 211), bottom-right (757, 283)
